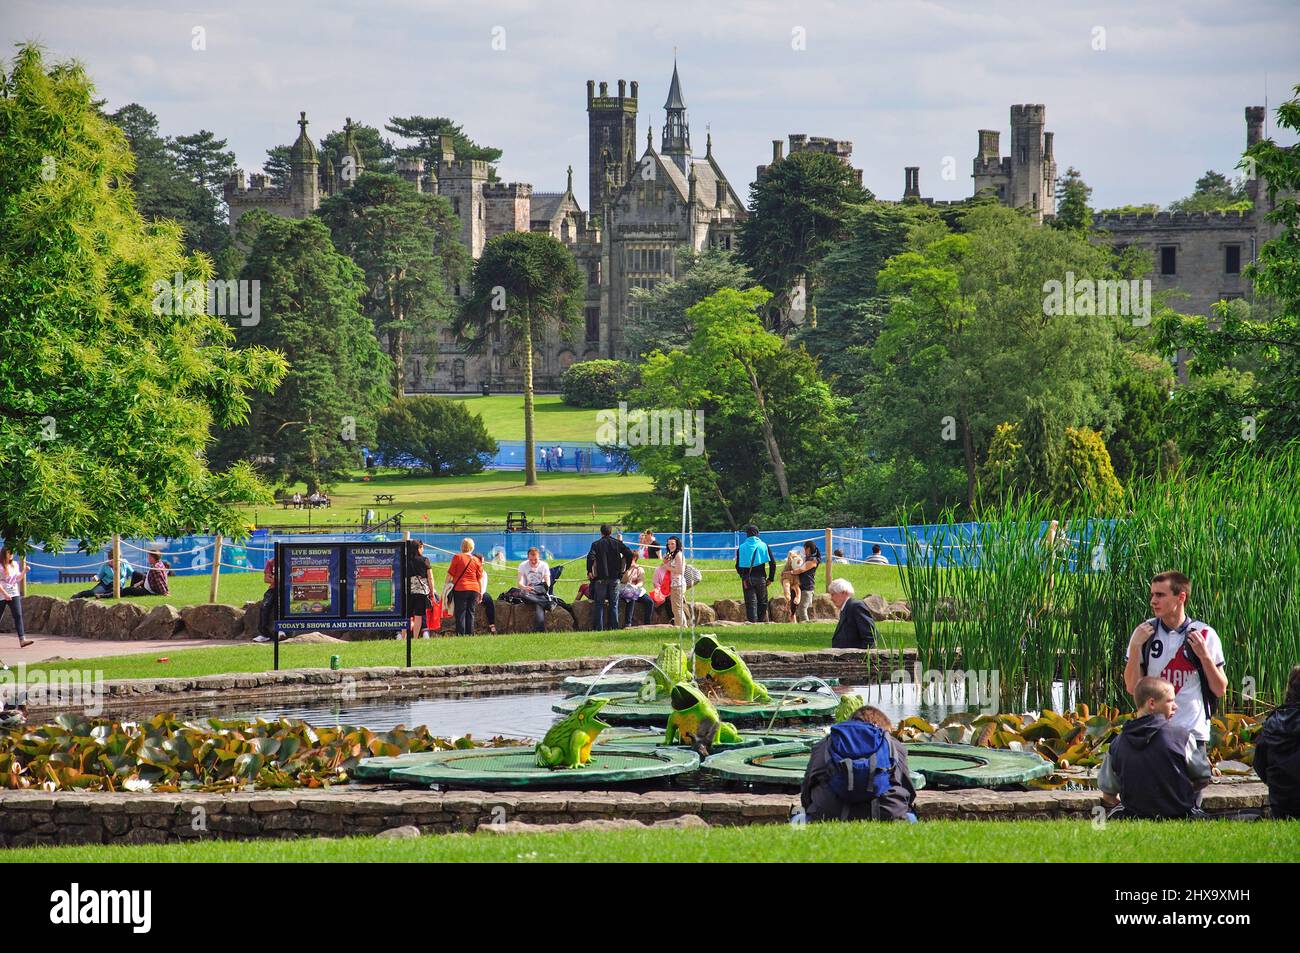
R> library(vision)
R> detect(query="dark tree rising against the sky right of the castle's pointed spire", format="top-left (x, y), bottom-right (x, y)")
top-left (740, 152), bottom-right (872, 334)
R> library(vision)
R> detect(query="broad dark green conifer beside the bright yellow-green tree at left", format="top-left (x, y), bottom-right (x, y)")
top-left (216, 212), bottom-right (393, 491)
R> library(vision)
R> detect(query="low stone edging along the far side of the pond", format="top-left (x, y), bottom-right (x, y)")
top-left (20, 642), bottom-right (917, 720)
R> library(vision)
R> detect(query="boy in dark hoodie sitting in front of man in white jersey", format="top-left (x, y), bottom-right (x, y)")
top-left (1097, 676), bottom-right (1210, 819)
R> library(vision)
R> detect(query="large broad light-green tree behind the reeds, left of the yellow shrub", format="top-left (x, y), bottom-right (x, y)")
top-left (862, 207), bottom-right (1130, 506)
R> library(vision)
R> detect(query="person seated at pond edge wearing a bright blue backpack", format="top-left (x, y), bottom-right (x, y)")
top-left (800, 705), bottom-right (917, 823)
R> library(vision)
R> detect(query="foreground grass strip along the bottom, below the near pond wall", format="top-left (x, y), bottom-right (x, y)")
top-left (0, 820), bottom-right (1300, 863)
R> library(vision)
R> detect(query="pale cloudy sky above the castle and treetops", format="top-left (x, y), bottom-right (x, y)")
top-left (0, 0), bottom-right (1300, 208)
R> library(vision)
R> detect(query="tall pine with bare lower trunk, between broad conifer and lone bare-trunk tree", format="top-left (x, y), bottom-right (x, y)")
top-left (317, 172), bottom-right (468, 397)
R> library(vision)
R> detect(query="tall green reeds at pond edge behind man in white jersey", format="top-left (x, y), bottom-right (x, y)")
top-left (902, 450), bottom-right (1300, 711)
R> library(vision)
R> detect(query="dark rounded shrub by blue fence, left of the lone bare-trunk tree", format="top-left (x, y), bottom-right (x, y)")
top-left (378, 397), bottom-right (497, 476)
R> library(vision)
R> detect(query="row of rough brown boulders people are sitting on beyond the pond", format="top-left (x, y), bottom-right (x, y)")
top-left (0, 593), bottom-right (911, 642)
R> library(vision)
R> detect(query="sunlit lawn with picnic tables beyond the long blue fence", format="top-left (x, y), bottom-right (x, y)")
top-left (244, 471), bottom-right (651, 532)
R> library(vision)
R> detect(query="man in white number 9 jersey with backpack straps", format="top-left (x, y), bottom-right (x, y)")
top-left (1125, 571), bottom-right (1227, 790)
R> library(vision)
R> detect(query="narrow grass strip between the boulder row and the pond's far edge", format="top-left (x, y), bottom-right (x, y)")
top-left (17, 623), bottom-right (915, 679)
